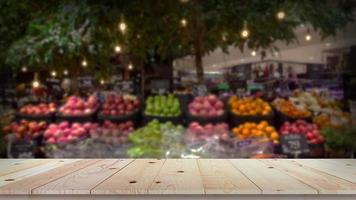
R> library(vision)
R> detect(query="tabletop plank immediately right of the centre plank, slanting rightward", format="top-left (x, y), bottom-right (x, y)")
top-left (198, 159), bottom-right (262, 194)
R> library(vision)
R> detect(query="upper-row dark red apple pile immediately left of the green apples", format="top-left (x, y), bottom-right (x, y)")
top-left (101, 94), bottom-right (140, 116)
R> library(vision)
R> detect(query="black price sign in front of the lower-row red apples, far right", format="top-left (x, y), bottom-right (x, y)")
top-left (281, 134), bottom-right (310, 157)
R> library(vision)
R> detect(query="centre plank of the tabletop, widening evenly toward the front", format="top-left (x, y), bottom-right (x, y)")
top-left (148, 159), bottom-right (204, 194)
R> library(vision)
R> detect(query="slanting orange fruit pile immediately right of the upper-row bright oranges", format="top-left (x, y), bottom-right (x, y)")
top-left (273, 99), bottom-right (311, 119)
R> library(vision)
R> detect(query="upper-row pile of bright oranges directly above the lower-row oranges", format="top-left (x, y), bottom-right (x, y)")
top-left (229, 96), bottom-right (272, 116)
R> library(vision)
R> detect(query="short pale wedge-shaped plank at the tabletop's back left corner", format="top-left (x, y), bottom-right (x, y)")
top-left (0, 159), bottom-right (48, 178)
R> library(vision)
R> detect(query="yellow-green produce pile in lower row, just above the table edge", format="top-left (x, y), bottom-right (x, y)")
top-left (128, 120), bottom-right (183, 158)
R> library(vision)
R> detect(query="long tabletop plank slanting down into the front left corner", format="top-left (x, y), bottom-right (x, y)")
top-left (0, 159), bottom-right (99, 195)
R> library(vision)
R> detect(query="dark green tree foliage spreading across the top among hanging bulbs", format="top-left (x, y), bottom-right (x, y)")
top-left (0, 0), bottom-right (354, 79)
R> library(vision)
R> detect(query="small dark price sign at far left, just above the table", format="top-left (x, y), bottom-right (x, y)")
top-left (10, 141), bottom-right (35, 158)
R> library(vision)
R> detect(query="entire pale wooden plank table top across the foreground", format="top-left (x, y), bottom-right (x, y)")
top-left (0, 159), bottom-right (356, 195)
